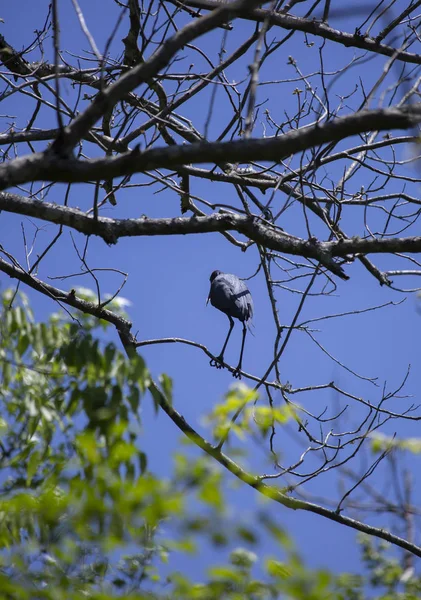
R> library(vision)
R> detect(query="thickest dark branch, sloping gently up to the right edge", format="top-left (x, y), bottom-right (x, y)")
top-left (0, 103), bottom-right (421, 189)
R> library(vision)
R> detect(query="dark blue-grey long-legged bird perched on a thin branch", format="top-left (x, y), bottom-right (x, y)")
top-left (206, 271), bottom-right (253, 379)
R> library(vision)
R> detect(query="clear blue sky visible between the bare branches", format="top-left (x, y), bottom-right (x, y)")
top-left (0, 0), bottom-right (421, 571)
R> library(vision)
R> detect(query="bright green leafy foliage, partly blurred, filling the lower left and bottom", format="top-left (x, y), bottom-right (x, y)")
top-left (0, 290), bottom-right (421, 600)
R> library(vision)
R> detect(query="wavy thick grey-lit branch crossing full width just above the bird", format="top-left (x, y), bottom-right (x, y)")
top-left (0, 192), bottom-right (421, 266)
